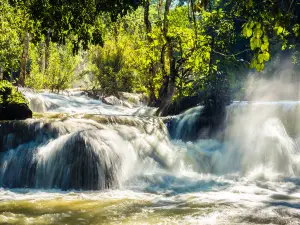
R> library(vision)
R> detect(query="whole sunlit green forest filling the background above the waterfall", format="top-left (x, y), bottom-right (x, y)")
top-left (0, 0), bottom-right (300, 114)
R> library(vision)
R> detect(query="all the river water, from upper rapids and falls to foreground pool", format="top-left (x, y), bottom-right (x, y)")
top-left (0, 90), bottom-right (300, 224)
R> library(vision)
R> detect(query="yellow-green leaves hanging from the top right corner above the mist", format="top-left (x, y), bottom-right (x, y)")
top-left (228, 0), bottom-right (300, 71)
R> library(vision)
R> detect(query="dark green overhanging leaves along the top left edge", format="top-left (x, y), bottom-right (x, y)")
top-left (10, 0), bottom-right (138, 52)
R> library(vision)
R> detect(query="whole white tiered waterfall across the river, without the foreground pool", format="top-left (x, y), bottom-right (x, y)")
top-left (0, 89), bottom-right (300, 190)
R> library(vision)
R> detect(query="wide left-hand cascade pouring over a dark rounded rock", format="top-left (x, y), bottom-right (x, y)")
top-left (0, 117), bottom-right (177, 190)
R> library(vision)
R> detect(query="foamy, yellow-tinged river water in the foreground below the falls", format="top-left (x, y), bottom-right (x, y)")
top-left (0, 175), bottom-right (300, 224)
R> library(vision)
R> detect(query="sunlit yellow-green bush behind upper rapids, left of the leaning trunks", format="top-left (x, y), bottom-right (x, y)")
top-left (88, 9), bottom-right (145, 95)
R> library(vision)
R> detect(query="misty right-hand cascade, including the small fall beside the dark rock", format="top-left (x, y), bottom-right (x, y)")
top-left (166, 101), bottom-right (300, 180)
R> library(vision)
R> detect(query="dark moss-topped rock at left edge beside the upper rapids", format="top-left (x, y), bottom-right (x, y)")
top-left (0, 80), bottom-right (32, 120)
